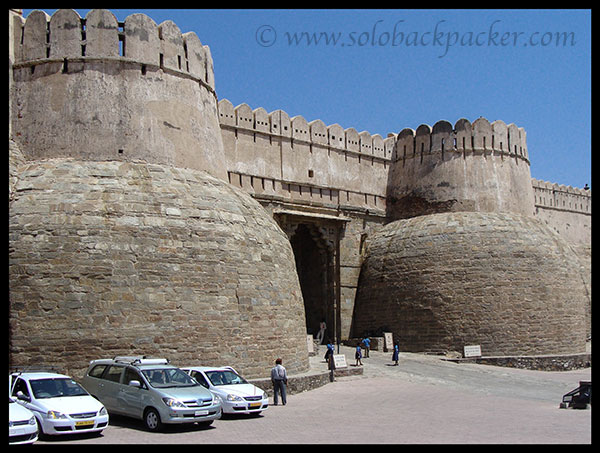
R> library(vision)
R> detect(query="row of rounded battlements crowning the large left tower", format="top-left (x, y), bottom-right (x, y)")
top-left (13, 9), bottom-right (215, 93)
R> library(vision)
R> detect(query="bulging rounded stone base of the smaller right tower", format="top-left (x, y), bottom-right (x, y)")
top-left (354, 212), bottom-right (589, 356)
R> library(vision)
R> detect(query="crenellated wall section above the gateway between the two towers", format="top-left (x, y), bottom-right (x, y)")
top-left (219, 99), bottom-right (394, 212)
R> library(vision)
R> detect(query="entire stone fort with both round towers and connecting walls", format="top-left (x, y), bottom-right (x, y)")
top-left (9, 10), bottom-right (591, 377)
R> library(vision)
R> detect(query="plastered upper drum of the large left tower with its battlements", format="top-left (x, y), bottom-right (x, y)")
top-left (9, 9), bottom-right (227, 179)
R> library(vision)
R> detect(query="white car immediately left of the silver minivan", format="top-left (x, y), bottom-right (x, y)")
top-left (9, 372), bottom-right (108, 435)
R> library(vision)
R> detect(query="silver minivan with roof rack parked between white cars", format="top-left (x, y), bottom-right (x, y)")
top-left (82, 356), bottom-right (222, 431)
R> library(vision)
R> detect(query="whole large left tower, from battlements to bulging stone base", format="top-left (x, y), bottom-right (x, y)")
top-left (9, 10), bottom-right (308, 377)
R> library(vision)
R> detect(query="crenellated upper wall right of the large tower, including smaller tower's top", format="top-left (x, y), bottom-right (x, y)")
top-left (218, 99), bottom-right (591, 238)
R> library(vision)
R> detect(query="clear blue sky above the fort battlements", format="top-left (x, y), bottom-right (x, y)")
top-left (24, 9), bottom-right (592, 187)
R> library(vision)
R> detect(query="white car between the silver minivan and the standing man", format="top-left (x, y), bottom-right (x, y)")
top-left (181, 366), bottom-right (269, 414)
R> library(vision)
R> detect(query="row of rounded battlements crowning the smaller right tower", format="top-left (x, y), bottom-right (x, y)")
top-left (392, 117), bottom-right (529, 163)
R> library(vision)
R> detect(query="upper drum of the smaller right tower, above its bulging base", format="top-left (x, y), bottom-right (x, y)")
top-left (387, 117), bottom-right (533, 219)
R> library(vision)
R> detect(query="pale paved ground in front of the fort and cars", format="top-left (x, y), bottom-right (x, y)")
top-left (39, 347), bottom-right (592, 444)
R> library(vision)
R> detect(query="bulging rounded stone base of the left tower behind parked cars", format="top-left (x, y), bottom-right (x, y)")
top-left (9, 159), bottom-right (308, 377)
